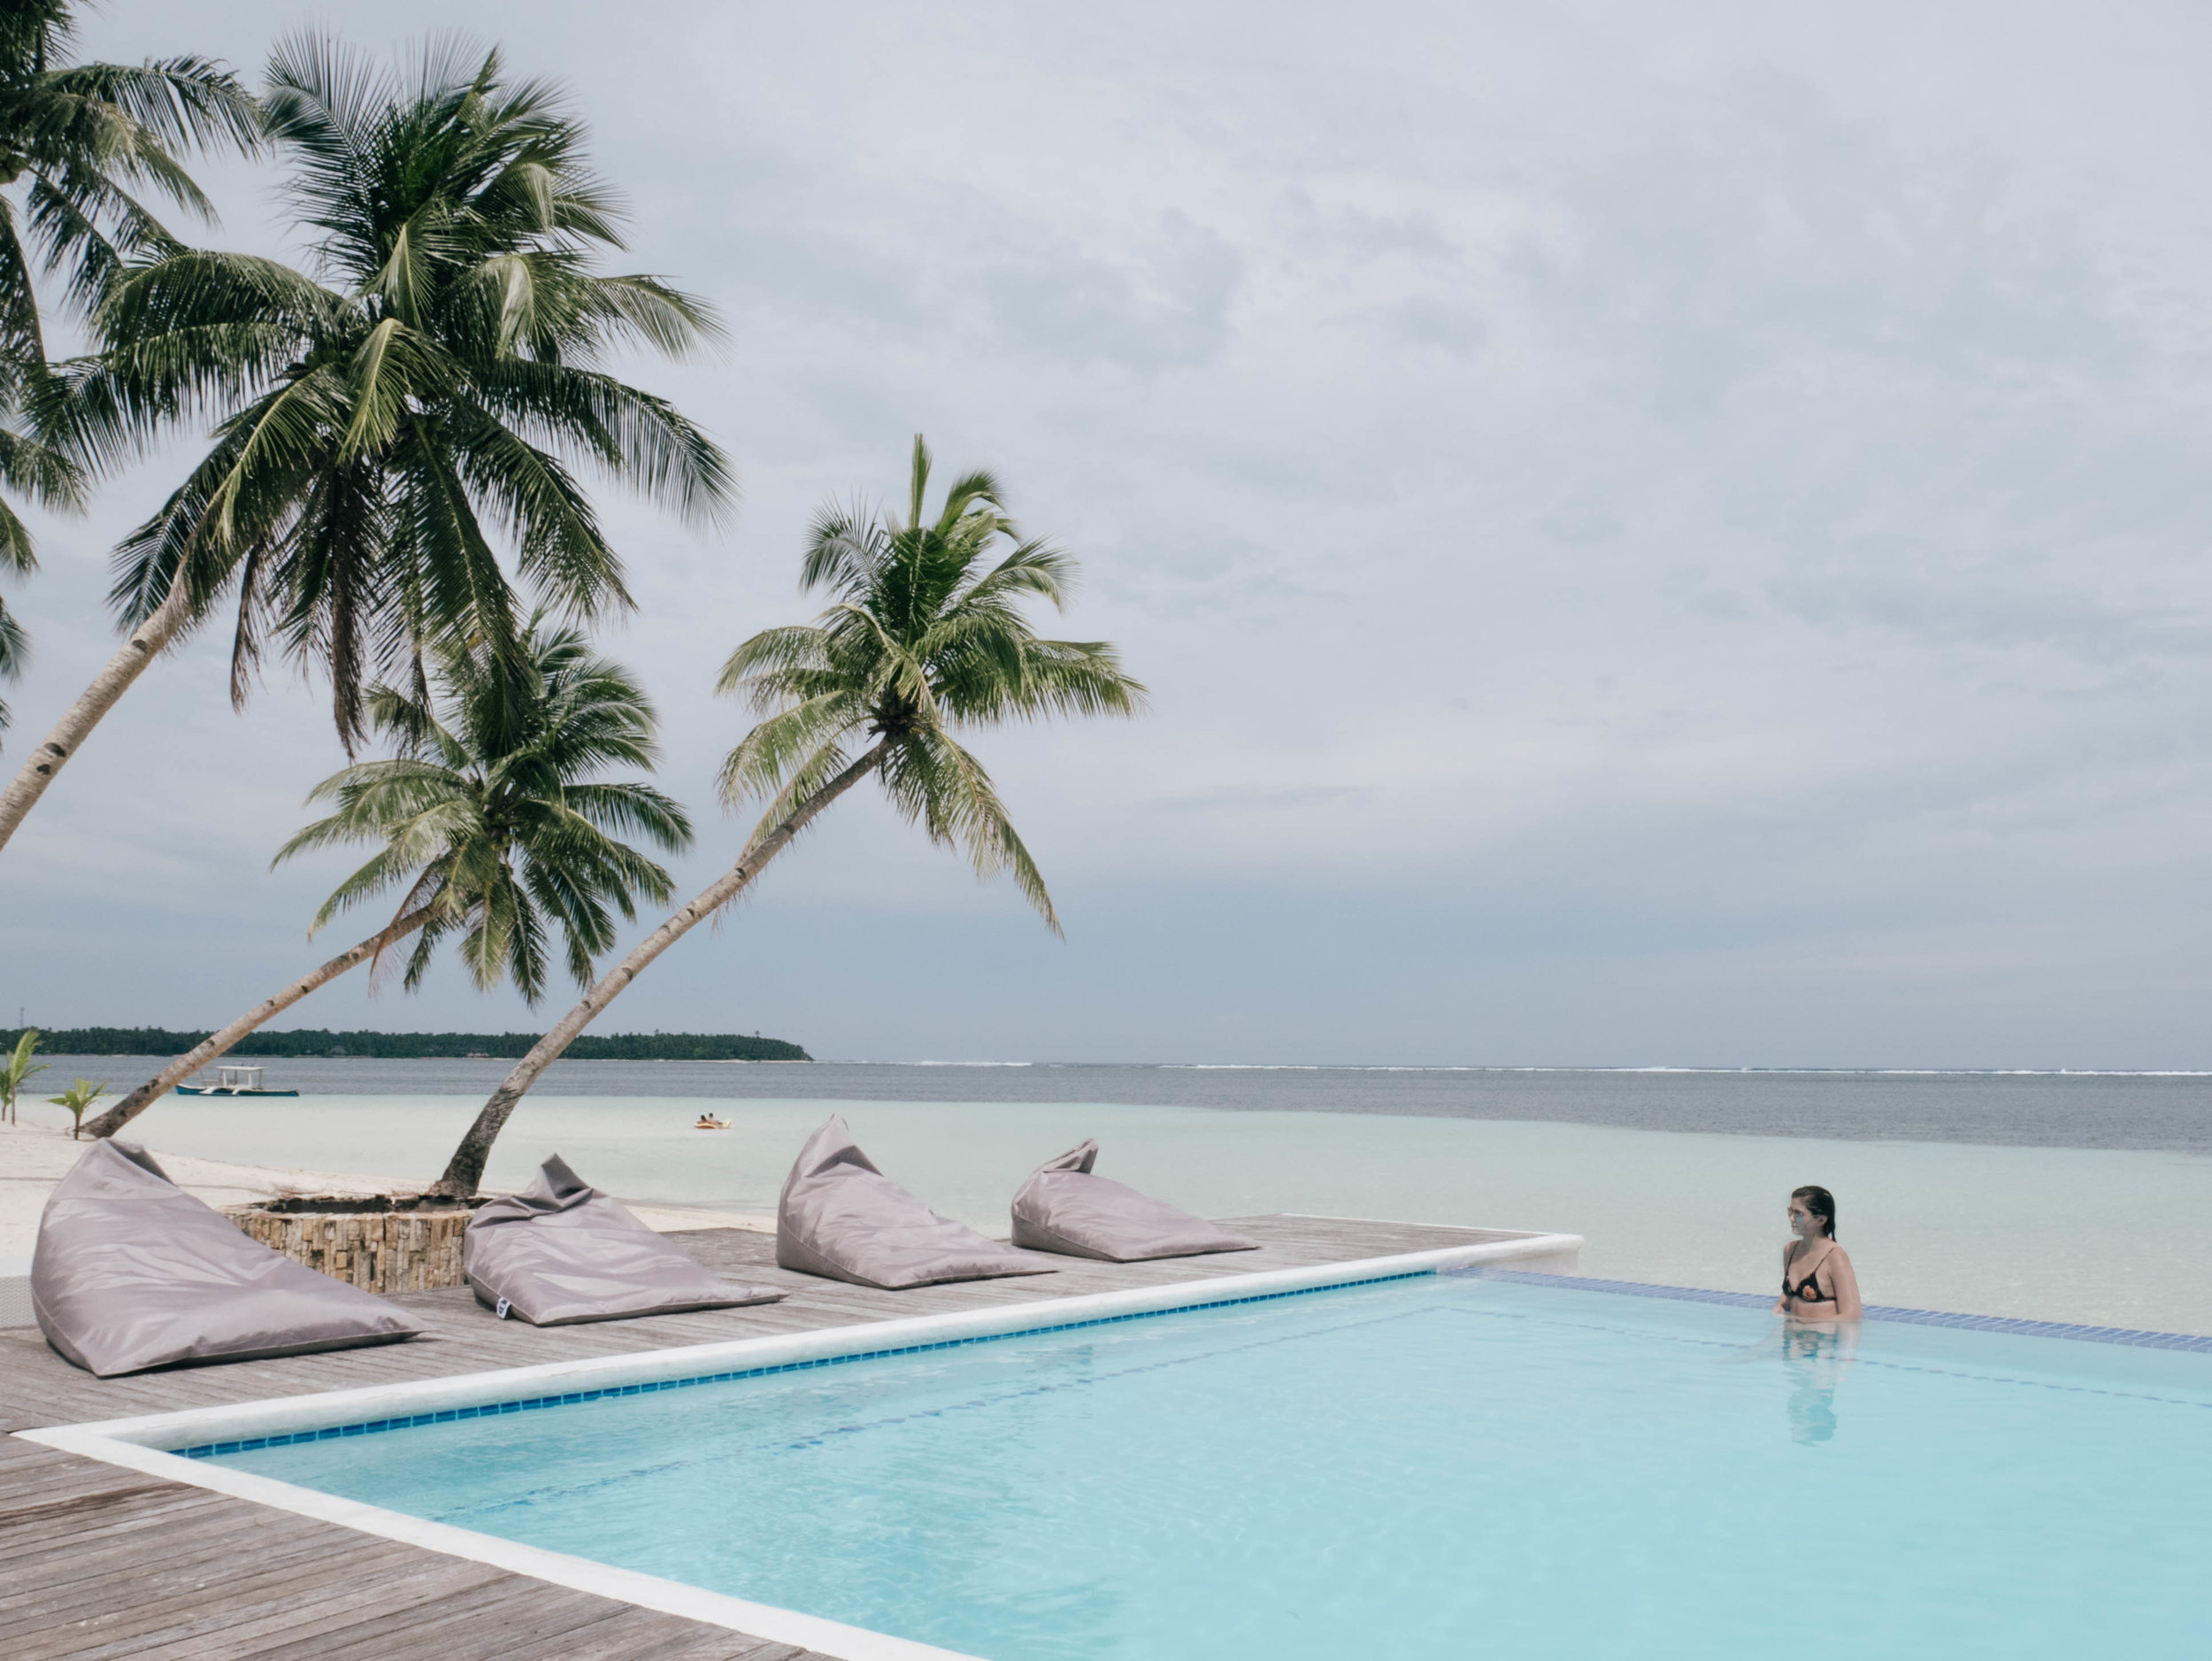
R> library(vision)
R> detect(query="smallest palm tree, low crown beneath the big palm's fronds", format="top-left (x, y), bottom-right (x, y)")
top-left (91, 619), bottom-right (693, 1137)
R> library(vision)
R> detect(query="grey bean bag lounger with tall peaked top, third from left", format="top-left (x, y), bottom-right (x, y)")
top-left (777, 1112), bottom-right (1053, 1292)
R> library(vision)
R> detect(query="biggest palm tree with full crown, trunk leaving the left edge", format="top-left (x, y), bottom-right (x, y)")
top-left (0, 35), bottom-right (733, 845)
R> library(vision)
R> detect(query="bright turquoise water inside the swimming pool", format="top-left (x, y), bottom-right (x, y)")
top-left (221, 1276), bottom-right (2212, 1661)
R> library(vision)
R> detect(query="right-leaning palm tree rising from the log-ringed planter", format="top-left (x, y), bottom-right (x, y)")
top-left (434, 435), bottom-right (1146, 1196)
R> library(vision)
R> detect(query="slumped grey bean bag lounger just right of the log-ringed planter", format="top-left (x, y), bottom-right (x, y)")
top-left (460, 1155), bottom-right (783, 1327)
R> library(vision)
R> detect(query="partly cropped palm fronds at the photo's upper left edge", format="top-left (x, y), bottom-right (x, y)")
top-left (0, 0), bottom-right (259, 727)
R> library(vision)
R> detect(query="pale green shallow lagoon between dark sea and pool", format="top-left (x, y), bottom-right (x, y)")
top-left (25, 1083), bottom-right (2212, 1334)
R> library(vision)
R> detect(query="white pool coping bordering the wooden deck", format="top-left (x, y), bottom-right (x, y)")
top-left (16, 1234), bottom-right (1582, 1661)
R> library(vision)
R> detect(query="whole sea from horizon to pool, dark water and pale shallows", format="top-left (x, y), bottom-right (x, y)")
top-left (25, 1057), bottom-right (2212, 1332)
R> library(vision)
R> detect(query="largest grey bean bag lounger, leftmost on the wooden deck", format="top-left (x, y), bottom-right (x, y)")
top-left (31, 1142), bottom-right (423, 1378)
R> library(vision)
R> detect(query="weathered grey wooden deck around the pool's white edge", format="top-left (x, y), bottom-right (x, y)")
top-left (0, 1217), bottom-right (1511, 1661)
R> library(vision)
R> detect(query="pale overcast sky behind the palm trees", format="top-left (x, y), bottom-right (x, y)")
top-left (0, 0), bottom-right (2212, 1068)
